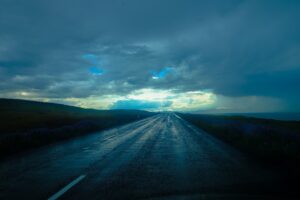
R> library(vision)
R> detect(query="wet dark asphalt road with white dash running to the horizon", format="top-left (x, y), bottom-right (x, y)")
top-left (0, 113), bottom-right (288, 200)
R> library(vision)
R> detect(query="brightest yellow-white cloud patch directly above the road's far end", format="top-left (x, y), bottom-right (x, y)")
top-left (69, 88), bottom-right (216, 111)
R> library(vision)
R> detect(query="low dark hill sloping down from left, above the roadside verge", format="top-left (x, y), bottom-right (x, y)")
top-left (0, 99), bottom-right (151, 134)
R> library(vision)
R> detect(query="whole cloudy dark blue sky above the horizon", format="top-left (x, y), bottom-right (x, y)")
top-left (0, 0), bottom-right (300, 112)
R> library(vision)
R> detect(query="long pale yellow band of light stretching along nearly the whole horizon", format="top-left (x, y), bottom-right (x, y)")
top-left (1, 88), bottom-right (285, 113)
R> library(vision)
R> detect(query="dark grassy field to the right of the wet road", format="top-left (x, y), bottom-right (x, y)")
top-left (178, 114), bottom-right (300, 171)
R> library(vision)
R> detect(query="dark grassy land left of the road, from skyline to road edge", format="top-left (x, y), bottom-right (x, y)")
top-left (0, 99), bottom-right (153, 157)
